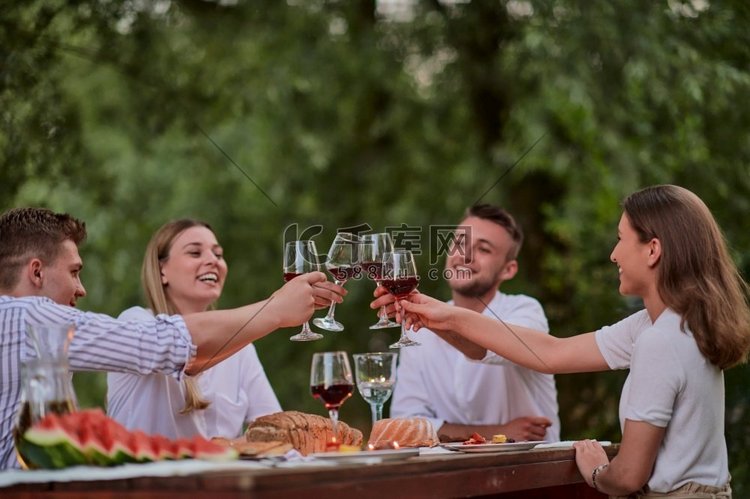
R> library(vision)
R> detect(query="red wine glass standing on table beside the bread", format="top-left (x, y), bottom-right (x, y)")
top-left (310, 352), bottom-right (354, 443)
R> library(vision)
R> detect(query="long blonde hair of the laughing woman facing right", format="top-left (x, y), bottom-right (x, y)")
top-left (141, 218), bottom-right (213, 414)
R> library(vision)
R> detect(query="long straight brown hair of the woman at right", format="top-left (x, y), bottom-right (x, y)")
top-left (624, 185), bottom-right (750, 369)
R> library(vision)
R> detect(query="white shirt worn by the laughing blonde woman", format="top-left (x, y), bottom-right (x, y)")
top-left (107, 307), bottom-right (281, 439)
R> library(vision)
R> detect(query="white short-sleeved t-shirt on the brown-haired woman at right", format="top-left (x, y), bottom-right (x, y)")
top-left (595, 309), bottom-right (729, 492)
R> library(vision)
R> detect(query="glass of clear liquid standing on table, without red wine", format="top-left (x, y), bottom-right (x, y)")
top-left (354, 352), bottom-right (398, 426)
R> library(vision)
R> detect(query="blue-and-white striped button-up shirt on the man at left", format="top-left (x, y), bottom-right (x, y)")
top-left (0, 296), bottom-right (196, 469)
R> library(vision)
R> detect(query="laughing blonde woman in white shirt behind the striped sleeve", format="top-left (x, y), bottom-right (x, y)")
top-left (107, 219), bottom-right (281, 438)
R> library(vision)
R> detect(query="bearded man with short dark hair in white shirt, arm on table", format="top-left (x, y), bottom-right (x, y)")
top-left (388, 204), bottom-right (560, 441)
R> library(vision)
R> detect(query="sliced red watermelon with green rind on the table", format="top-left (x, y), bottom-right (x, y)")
top-left (16, 409), bottom-right (237, 469)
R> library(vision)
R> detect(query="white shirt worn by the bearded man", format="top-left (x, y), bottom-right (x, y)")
top-left (391, 292), bottom-right (560, 441)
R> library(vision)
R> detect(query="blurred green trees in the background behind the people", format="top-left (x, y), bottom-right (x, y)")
top-left (0, 0), bottom-right (750, 497)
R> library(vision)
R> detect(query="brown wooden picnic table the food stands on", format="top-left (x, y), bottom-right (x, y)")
top-left (0, 446), bottom-right (617, 499)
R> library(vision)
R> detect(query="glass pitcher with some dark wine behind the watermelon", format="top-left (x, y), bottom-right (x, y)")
top-left (13, 324), bottom-right (77, 468)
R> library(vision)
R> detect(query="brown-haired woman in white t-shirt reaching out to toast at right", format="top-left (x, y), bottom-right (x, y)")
top-left (396, 185), bottom-right (750, 498)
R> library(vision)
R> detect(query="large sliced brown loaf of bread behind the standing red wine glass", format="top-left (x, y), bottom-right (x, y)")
top-left (245, 411), bottom-right (362, 455)
